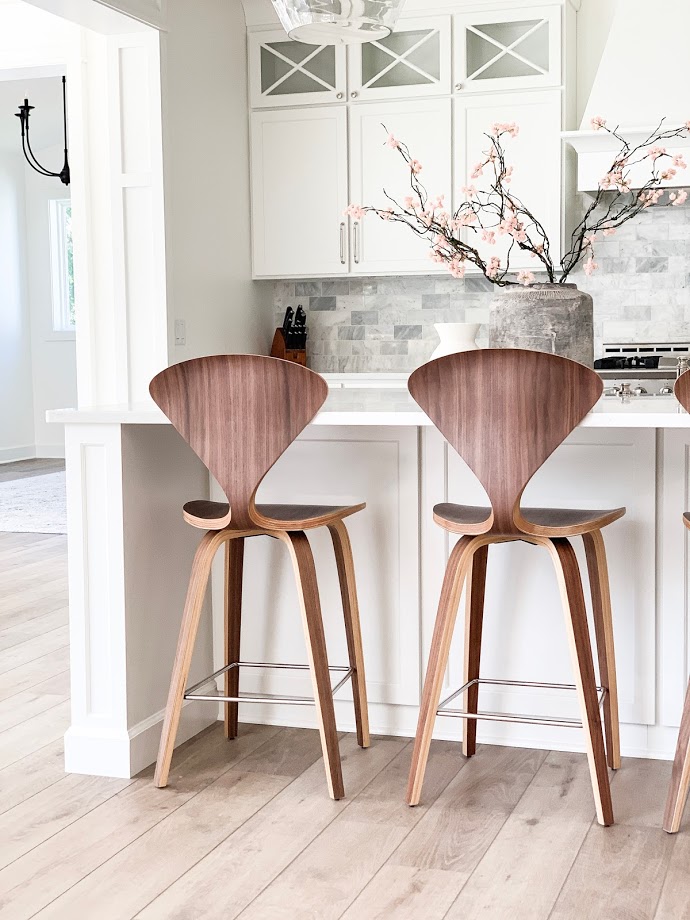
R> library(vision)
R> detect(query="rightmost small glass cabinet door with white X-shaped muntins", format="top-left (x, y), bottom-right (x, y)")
top-left (454, 6), bottom-right (561, 92)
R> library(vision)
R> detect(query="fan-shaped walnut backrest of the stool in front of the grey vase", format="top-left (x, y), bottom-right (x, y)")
top-left (408, 348), bottom-right (603, 535)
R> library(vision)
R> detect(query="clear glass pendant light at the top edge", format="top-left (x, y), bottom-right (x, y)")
top-left (273, 0), bottom-right (405, 45)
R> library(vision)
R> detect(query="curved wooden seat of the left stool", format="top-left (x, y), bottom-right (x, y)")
top-left (182, 500), bottom-right (366, 533)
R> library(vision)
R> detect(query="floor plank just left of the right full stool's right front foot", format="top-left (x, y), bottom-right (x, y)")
top-left (446, 753), bottom-right (595, 920)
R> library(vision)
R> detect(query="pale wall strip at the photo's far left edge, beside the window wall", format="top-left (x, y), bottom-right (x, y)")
top-left (0, 153), bottom-right (34, 462)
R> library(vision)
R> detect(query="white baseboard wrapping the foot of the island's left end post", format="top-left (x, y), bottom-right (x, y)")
top-left (65, 700), bottom-right (215, 779)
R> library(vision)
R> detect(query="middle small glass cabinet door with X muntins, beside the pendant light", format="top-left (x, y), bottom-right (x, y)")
top-left (348, 16), bottom-right (451, 99)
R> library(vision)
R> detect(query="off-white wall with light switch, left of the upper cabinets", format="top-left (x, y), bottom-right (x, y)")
top-left (161, 0), bottom-right (272, 363)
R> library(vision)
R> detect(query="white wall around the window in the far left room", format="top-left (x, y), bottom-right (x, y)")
top-left (25, 146), bottom-right (77, 457)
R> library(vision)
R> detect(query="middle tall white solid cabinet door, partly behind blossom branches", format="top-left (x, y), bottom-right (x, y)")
top-left (350, 99), bottom-right (451, 274)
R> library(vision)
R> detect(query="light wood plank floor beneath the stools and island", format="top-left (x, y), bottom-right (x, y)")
top-left (0, 520), bottom-right (690, 920)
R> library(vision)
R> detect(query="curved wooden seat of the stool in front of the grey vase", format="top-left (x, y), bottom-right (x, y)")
top-left (434, 502), bottom-right (624, 537)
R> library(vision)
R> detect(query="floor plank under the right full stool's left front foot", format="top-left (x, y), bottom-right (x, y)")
top-left (240, 742), bottom-right (466, 920)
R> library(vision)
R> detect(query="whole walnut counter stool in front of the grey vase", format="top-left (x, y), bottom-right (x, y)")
top-left (407, 349), bottom-right (625, 825)
